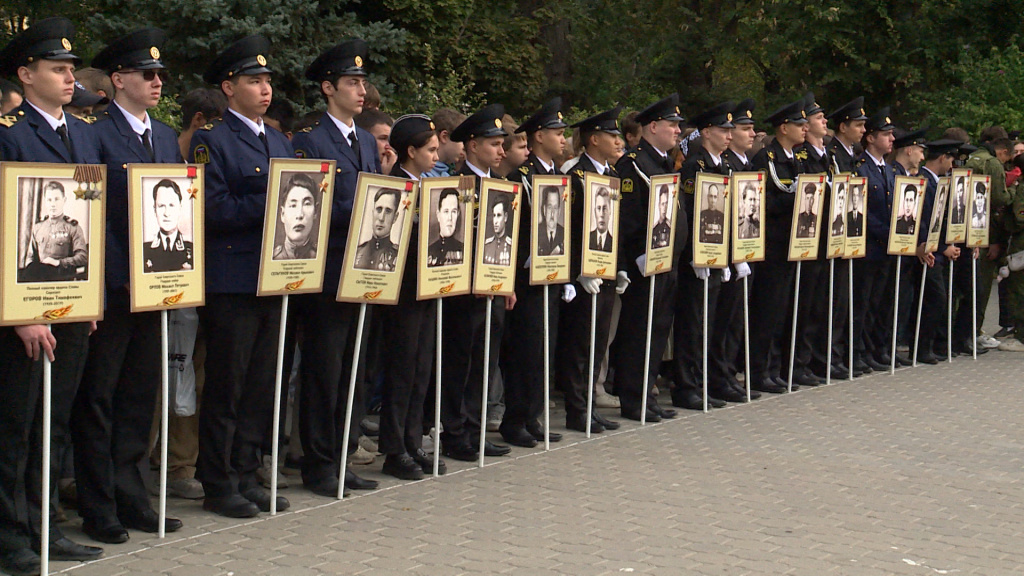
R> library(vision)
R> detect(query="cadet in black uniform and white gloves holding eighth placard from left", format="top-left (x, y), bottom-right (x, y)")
top-left (555, 107), bottom-right (622, 433)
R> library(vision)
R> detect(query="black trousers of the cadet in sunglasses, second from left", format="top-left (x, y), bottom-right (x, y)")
top-left (71, 289), bottom-right (159, 526)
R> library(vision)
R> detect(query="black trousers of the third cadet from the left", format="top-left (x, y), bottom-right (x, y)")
top-left (196, 294), bottom-right (280, 498)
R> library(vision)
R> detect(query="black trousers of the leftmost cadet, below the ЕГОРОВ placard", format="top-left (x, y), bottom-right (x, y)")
top-left (0, 323), bottom-right (88, 552)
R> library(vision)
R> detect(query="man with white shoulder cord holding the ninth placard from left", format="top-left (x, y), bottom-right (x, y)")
top-left (611, 94), bottom-right (689, 416)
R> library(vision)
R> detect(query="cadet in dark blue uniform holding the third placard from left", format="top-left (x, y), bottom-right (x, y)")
top-left (189, 36), bottom-right (294, 518)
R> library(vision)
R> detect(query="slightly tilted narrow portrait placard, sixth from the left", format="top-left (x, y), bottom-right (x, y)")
top-left (473, 178), bottom-right (522, 296)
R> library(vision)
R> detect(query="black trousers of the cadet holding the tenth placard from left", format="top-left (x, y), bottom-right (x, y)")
top-left (671, 263), bottom-right (722, 391)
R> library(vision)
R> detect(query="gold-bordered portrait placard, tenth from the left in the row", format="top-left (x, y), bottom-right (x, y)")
top-left (692, 172), bottom-right (730, 269)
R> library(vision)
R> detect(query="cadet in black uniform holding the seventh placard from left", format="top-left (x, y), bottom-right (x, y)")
top-left (499, 98), bottom-right (580, 448)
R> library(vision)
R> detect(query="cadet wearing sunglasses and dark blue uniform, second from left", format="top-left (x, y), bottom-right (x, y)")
top-left (72, 28), bottom-right (182, 543)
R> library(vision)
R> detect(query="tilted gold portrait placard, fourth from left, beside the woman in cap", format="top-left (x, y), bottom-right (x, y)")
top-left (337, 172), bottom-right (418, 304)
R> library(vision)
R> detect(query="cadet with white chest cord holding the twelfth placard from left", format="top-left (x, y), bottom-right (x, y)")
top-left (746, 98), bottom-right (807, 394)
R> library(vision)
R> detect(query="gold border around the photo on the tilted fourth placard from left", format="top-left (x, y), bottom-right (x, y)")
top-left (335, 172), bottom-right (419, 304)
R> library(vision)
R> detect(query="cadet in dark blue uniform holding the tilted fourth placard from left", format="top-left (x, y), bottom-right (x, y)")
top-left (293, 39), bottom-right (381, 498)
